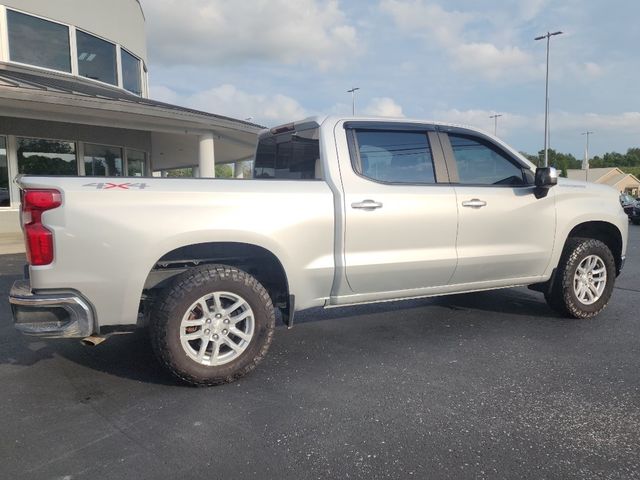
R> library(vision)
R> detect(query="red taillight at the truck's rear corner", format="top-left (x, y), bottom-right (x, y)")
top-left (22, 190), bottom-right (62, 265)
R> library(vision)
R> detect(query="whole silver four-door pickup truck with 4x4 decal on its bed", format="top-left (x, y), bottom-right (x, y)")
top-left (10, 117), bottom-right (628, 385)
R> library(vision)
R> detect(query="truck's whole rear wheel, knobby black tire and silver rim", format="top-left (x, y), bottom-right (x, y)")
top-left (151, 265), bottom-right (275, 386)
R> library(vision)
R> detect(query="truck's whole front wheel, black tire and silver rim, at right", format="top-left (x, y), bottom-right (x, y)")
top-left (545, 238), bottom-right (616, 318)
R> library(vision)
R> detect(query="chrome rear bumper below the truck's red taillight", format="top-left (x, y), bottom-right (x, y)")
top-left (9, 280), bottom-right (96, 338)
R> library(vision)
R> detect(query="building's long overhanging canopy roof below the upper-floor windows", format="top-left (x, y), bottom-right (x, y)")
top-left (0, 63), bottom-right (264, 168)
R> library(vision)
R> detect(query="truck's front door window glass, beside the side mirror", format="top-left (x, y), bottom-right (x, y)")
top-left (449, 133), bottom-right (525, 186)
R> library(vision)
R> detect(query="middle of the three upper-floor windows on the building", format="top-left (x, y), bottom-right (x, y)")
top-left (76, 30), bottom-right (118, 85)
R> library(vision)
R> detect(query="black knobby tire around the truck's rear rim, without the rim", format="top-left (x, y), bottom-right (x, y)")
top-left (149, 265), bottom-right (275, 386)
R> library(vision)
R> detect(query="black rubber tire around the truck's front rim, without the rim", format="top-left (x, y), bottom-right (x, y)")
top-left (545, 237), bottom-right (616, 318)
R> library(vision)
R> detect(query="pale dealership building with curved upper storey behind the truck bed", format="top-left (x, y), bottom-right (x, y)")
top-left (0, 0), bottom-right (261, 234)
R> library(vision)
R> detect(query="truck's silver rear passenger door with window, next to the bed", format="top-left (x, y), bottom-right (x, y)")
top-left (337, 122), bottom-right (458, 296)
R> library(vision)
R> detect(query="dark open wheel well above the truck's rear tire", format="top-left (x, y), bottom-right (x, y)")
top-left (144, 242), bottom-right (290, 318)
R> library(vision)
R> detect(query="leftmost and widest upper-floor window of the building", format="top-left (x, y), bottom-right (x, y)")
top-left (7, 10), bottom-right (71, 73)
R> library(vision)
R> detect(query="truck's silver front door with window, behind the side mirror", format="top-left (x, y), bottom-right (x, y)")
top-left (441, 128), bottom-right (556, 284)
